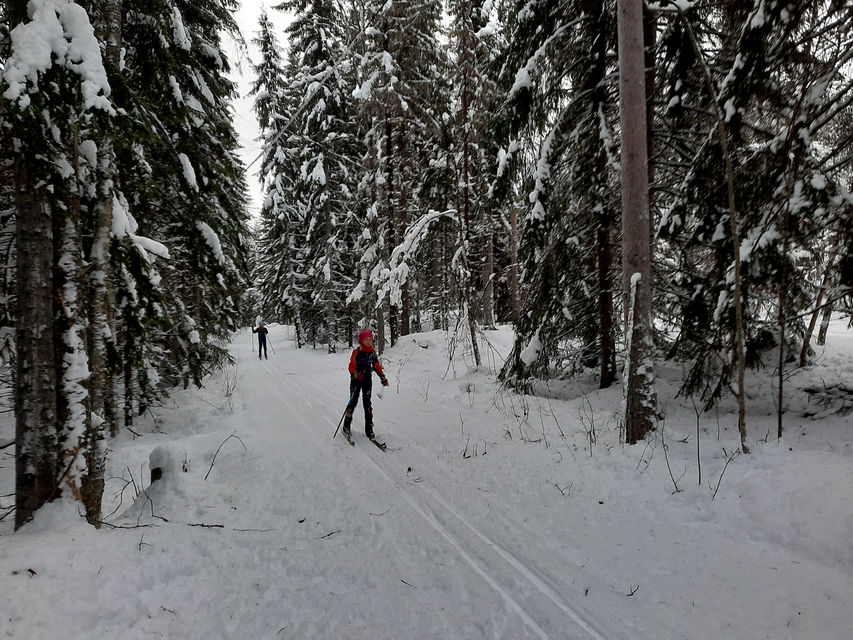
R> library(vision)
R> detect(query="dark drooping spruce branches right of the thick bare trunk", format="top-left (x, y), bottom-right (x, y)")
top-left (656, 2), bottom-right (853, 418)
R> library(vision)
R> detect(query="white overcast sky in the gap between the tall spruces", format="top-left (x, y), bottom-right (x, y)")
top-left (223, 0), bottom-right (288, 217)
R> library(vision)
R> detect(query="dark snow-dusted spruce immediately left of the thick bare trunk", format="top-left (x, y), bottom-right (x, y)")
top-left (498, 0), bottom-right (619, 387)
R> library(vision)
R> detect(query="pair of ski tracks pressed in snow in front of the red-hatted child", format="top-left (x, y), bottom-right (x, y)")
top-left (286, 378), bottom-right (612, 640)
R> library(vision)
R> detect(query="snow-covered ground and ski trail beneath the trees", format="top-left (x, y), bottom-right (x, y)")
top-left (0, 323), bottom-right (853, 640)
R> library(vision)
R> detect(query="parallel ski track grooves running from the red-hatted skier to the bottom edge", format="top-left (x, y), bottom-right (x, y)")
top-left (286, 368), bottom-right (607, 640)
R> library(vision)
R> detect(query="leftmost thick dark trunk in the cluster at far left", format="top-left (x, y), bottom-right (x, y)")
top-left (15, 157), bottom-right (62, 529)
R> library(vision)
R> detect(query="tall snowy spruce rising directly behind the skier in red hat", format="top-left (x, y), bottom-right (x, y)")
top-left (350, 0), bottom-right (448, 346)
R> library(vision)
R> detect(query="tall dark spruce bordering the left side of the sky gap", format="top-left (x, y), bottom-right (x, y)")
top-left (125, 0), bottom-right (248, 385)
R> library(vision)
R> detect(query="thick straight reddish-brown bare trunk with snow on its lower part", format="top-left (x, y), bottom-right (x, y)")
top-left (618, 0), bottom-right (657, 444)
